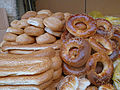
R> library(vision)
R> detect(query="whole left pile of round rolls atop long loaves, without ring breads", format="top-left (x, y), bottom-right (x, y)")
top-left (0, 10), bottom-right (70, 90)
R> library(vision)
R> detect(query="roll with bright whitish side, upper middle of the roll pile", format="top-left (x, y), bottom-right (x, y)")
top-left (27, 17), bottom-right (44, 28)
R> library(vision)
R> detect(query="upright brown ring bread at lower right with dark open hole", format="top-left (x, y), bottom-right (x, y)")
top-left (86, 52), bottom-right (113, 86)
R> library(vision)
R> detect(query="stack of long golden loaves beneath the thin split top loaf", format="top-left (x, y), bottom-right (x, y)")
top-left (0, 48), bottom-right (62, 90)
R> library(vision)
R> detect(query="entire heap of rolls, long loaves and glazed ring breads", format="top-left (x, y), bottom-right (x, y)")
top-left (0, 10), bottom-right (120, 90)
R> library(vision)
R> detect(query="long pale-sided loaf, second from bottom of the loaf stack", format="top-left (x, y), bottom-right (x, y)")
top-left (0, 69), bottom-right (53, 85)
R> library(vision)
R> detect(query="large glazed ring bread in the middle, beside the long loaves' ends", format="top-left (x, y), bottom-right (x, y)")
top-left (60, 37), bottom-right (91, 67)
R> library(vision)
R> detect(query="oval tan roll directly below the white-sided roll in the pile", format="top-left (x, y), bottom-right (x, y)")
top-left (24, 26), bottom-right (44, 36)
